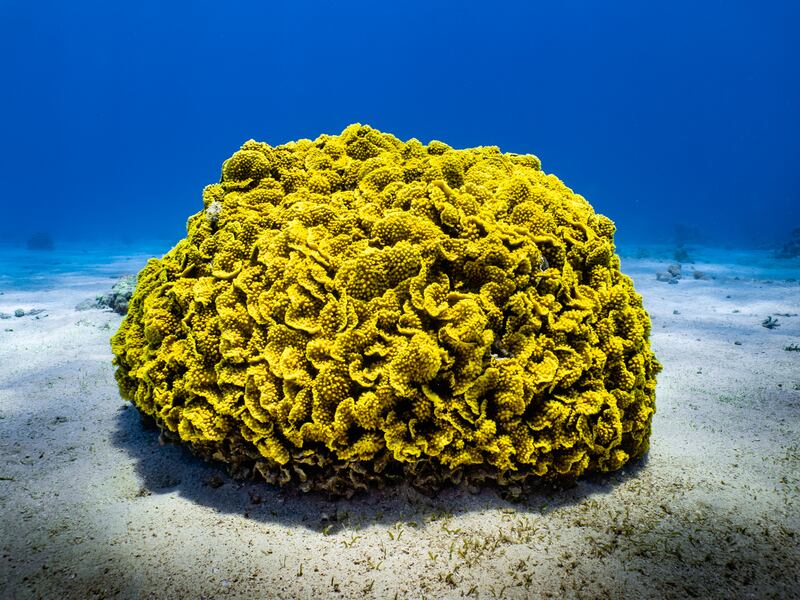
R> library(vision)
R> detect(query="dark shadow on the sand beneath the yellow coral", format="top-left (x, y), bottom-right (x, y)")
top-left (112, 404), bottom-right (647, 533)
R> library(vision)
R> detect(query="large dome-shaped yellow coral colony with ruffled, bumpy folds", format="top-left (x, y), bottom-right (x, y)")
top-left (111, 125), bottom-right (660, 493)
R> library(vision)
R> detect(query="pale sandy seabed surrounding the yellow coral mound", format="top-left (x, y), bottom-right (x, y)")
top-left (0, 241), bottom-right (800, 600)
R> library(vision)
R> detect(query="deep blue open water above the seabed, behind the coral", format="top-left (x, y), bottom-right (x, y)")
top-left (0, 0), bottom-right (800, 244)
